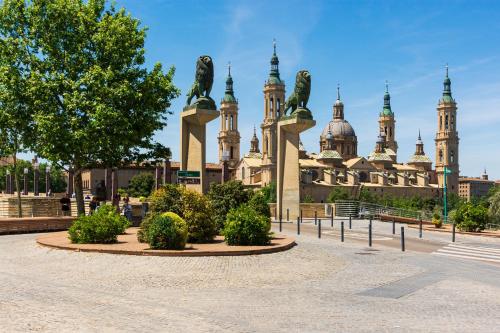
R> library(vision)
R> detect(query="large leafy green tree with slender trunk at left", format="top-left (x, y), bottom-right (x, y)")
top-left (0, 0), bottom-right (179, 214)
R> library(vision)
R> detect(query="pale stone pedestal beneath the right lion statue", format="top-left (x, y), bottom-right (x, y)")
top-left (276, 118), bottom-right (316, 221)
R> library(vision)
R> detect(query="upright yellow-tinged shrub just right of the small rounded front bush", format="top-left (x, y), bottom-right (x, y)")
top-left (181, 189), bottom-right (217, 243)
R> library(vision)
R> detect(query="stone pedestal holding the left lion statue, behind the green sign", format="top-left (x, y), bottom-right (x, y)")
top-left (180, 105), bottom-right (220, 193)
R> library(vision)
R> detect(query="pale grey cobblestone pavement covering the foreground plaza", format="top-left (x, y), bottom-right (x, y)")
top-left (0, 230), bottom-right (500, 332)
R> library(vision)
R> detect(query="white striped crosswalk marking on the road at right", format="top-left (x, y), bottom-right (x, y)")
top-left (433, 244), bottom-right (500, 263)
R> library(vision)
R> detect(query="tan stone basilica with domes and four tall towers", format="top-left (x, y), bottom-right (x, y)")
top-left (218, 46), bottom-right (459, 202)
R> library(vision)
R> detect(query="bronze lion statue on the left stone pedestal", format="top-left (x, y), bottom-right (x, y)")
top-left (186, 55), bottom-right (215, 107)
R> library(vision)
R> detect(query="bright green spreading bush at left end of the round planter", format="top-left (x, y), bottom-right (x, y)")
top-left (68, 205), bottom-right (130, 244)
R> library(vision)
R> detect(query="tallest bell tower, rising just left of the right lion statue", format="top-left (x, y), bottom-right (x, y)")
top-left (260, 41), bottom-right (285, 186)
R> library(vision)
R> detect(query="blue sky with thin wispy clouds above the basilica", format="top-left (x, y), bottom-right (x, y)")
top-left (116, 0), bottom-right (500, 179)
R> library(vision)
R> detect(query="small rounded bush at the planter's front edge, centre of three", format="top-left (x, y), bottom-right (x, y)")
top-left (147, 212), bottom-right (188, 250)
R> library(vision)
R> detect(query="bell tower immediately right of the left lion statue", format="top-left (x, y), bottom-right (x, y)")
top-left (218, 63), bottom-right (240, 168)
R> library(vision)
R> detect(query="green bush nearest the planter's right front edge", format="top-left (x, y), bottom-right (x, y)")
top-left (223, 204), bottom-right (271, 245)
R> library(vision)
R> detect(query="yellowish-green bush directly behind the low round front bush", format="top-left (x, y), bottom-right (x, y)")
top-left (149, 184), bottom-right (183, 217)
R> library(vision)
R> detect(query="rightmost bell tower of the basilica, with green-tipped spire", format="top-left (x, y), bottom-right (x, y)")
top-left (435, 65), bottom-right (460, 193)
